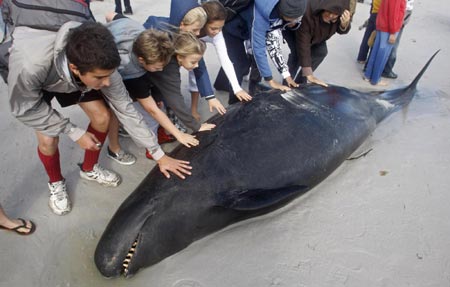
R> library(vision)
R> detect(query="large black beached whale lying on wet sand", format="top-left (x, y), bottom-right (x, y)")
top-left (95, 52), bottom-right (437, 277)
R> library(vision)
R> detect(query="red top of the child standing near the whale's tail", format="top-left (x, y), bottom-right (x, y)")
top-left (377, 0), bottom-right (406, 34)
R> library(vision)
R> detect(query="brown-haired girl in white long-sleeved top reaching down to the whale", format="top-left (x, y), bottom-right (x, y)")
top-left (189, 0), bottom-right (252, 120)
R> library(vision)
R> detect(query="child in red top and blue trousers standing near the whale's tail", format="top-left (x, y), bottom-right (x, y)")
top-left (363, 0), bottom-right (406, 86)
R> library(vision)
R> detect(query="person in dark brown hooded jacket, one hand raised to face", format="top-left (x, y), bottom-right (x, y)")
top-left (283, 0), bottom-right (351, 87)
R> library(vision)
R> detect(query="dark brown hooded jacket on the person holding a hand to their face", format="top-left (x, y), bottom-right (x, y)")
top-left (295, 0), bottom-right (350, 67)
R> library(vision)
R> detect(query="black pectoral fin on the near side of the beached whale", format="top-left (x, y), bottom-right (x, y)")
top-left (217, 185), bottom-right (308, 210)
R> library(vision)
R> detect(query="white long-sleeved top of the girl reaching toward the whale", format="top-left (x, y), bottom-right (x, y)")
top-left (189, 31), bottom-right (242, 94)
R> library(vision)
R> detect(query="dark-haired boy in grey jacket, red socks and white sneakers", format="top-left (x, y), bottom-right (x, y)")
top-left (8, 22), bottom-right (191, 215)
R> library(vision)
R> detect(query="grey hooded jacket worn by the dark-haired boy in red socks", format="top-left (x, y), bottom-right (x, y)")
top-left (8, 22), bottom-right (164, 160)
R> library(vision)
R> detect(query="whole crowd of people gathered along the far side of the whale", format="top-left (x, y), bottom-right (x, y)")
top-left (0, 0), bottom-right (414, 235)
